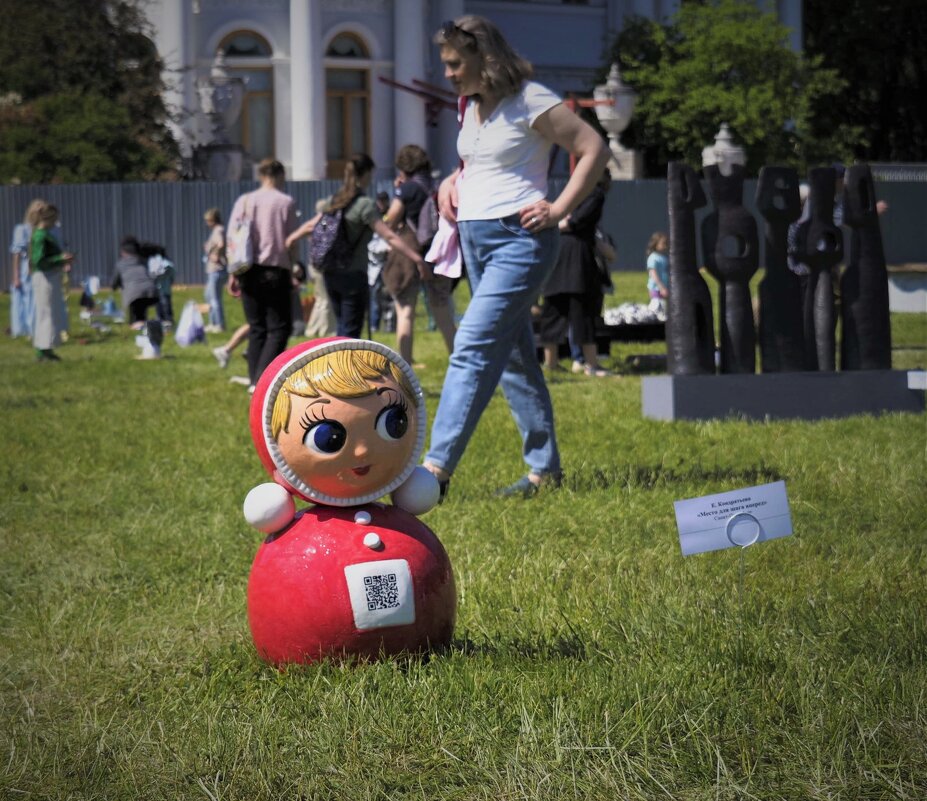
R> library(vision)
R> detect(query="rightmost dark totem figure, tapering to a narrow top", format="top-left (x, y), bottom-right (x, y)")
top-left (840, 164), bottom-right (892, 370)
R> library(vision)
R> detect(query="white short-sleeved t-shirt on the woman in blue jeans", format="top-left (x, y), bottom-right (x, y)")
top-left (457, 81), bottom-right (562, 221)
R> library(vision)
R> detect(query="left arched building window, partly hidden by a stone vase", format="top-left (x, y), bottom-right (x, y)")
top-left (219, 31), bottom-right (274, 161)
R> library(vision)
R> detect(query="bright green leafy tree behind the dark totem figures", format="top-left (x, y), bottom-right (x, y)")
top-left (603, 0), bottom-right (858, 175)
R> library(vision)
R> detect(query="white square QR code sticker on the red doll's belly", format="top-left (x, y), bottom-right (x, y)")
top-left (344, 559), bottom-right (415, 631)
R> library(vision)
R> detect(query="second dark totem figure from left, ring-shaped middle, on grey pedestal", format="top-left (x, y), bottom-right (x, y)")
top-left (704, 164), bottom-right (760, 373)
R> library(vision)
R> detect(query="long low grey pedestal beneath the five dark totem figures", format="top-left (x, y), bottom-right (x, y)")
top-left (641, 370), bottom-right (924, 420)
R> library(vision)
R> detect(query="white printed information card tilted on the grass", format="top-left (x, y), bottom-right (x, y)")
top-left (673, 481), bottom-right (792, 556)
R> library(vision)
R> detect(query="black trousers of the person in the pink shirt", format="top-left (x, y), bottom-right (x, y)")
top-left (238, 264), bottom-right (293, 384)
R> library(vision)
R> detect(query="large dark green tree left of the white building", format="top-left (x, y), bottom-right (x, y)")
top-left (0, 0), bottom-right (177, 183)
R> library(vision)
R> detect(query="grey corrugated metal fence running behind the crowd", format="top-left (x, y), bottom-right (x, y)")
top-left (0, 180), bottom-right (927, 284)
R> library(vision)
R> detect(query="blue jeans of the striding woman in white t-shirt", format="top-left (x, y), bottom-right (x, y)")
top-left (425, 214), bottom-right (560, 475)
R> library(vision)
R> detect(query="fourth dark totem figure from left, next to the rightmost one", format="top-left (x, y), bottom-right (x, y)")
top-left (798, 167), bottom-right (843, 371)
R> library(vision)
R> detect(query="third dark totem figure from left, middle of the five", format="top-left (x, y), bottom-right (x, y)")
top-left (756, 167), bottom-right (805, 373)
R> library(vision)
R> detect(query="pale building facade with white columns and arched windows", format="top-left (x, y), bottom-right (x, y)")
top-left (146, 0), bottom-right (802, 180)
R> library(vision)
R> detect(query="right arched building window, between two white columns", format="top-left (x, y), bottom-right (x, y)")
top-left (325, 33), bottom-right (370, 178)
